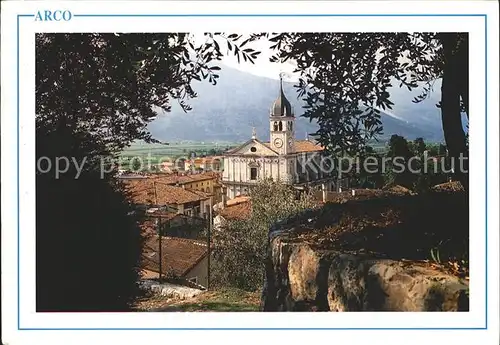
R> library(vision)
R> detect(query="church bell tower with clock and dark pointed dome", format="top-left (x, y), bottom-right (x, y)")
top-left (269, 75), bottom-right (295, 155)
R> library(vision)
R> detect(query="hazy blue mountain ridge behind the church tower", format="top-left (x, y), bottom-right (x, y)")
top-left (148, 66), bottom-right (443, 142)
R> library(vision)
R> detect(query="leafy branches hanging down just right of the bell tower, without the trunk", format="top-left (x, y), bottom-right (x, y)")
top-left (250, 33), bottom-right (446, 153)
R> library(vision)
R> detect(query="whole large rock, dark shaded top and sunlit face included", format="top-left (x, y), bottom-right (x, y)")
top-left (262, 190), bottom-right (469, 311)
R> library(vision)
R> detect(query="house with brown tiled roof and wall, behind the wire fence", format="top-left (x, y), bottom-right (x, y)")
top-left (141, 235), bottom-right (208, 287)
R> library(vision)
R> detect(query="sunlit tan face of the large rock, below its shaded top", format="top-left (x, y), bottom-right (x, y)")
top-left (262, 231), bottom-right (469, 311)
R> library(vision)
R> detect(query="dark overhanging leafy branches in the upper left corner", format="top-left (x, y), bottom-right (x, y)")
top-left (36, 33), bottom-right (259, 151)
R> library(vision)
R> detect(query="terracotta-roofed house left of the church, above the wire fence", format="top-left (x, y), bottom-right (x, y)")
top-left (124, 177), bottom-right (212, 218)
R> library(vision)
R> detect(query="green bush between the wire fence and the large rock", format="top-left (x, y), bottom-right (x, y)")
top-left (211, 180), bottom-right (315, 291)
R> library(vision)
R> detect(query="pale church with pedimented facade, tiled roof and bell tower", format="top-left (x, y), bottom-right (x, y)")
top-left (222, 78), bottom-right (335, 199)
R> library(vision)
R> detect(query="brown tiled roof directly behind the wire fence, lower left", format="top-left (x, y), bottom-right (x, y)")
top-left (141, 235), bottom-right (208, 277)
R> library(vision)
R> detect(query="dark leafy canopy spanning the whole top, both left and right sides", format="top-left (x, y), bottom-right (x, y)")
top-left (36, 33), bottom-right (468, 189)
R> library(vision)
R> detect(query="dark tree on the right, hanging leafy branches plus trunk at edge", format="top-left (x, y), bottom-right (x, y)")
top-left (251, 32), bottom-right (469, 190)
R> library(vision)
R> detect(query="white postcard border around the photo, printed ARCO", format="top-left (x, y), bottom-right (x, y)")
top-left (2, 1), bottom-right (498, 343)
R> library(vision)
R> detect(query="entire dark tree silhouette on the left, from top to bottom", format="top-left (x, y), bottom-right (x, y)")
top-left (35, 33), bottom-right (259, 311)
